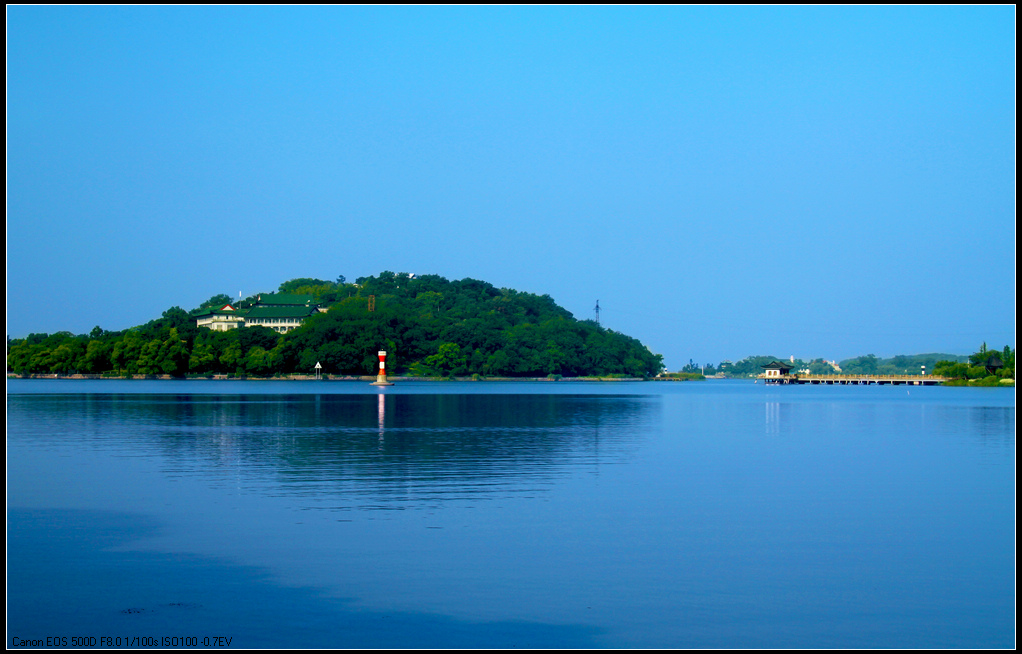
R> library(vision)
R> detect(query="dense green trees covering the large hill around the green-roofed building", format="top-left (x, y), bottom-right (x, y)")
top-left (7, 272), bottom-right (663, 377)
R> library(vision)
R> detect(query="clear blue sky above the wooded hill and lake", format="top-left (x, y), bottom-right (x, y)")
top-left (7, 6), bottom-right (1015, 370)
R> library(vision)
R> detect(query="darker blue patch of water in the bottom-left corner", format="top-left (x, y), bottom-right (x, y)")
top-left (7, 509), bottom-right (599, 649)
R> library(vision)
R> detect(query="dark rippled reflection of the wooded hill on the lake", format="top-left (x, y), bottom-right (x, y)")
top-left (8, 393), bottom-right (659, 507)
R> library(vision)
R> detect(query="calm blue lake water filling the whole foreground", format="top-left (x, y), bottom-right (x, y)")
top-left (7, 380), bottom-right (1015, 648)
